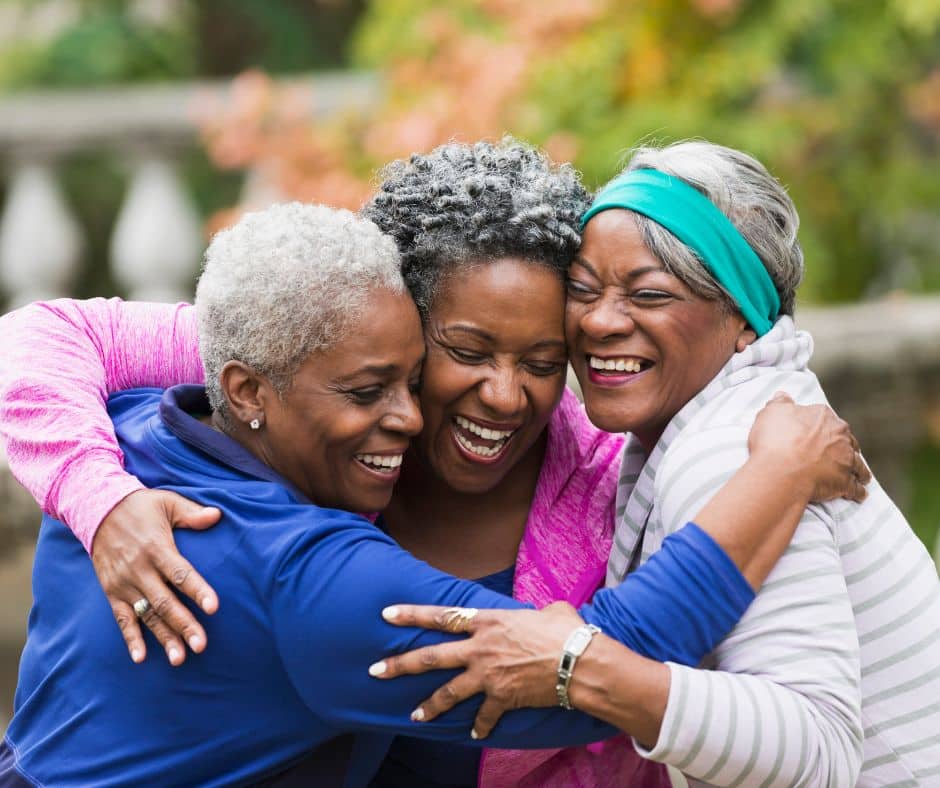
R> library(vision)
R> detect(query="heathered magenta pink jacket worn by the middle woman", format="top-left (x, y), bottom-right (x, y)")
top-left (0, 299), bottom-right (669, 788)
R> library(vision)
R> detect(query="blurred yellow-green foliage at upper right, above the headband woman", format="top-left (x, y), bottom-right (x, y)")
top-left (355, 0), bottom-right (940, 302)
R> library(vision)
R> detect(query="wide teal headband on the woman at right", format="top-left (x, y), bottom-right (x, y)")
top-left (581, 170), bottom-right (780, 336)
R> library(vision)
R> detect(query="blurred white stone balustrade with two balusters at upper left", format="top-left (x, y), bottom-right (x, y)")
top-left (0, 73), bottom-right (378, 308)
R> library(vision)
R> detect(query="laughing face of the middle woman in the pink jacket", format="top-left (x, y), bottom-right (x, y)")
top-left (415, 257), bottom-right (567, 493)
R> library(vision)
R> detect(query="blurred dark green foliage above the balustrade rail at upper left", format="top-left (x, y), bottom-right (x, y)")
top-left (0, 0), bottom-right (362, 90)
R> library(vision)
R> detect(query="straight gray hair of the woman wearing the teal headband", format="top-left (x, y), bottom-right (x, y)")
top-left (625, 140), bottom-right (803, 315)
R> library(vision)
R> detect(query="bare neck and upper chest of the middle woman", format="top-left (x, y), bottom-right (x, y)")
top-left (384, 433), bottom-right (547, 579)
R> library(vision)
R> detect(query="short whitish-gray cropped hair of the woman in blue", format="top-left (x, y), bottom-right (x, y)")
top-left (196, 202), bottom-right (405, 424)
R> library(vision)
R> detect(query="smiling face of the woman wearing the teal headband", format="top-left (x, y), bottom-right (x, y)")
top-left (565, 209), bottom-right (754, 451)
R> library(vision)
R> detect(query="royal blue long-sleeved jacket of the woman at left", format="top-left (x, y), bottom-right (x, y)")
top-left (0, 386), bottom-right (753, 786)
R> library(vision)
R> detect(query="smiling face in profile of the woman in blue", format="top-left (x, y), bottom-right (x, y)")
top-left (251, 289), bottom-right (424, 512)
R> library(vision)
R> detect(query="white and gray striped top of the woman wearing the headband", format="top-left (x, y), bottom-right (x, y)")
top-left (607, 317), bottom-right (940, 788)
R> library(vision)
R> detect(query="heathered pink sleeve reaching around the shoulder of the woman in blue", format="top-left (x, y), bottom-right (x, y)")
top-left (0, 298), bottom-right (203, 553)
